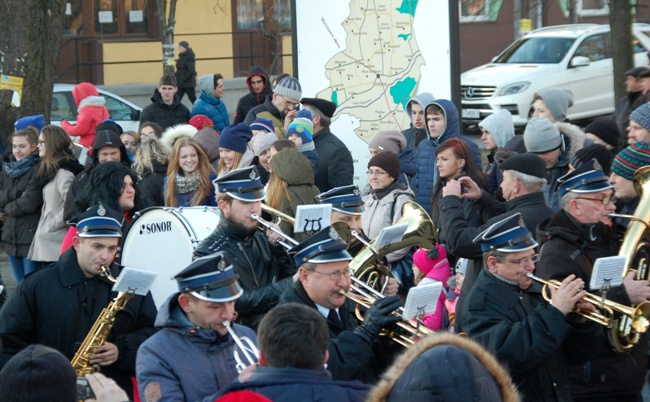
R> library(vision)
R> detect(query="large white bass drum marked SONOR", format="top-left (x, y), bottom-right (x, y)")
top-left (120, 207), bottom-right (221, 308)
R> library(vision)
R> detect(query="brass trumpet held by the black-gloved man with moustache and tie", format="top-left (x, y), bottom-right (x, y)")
top-left (339, 276), bottom-right (433, 347)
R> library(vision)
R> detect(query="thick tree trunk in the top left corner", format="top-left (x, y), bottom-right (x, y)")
top-left (0, 0), bottom-right (65, 148)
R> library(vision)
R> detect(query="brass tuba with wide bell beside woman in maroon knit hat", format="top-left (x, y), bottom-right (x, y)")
top-left (350, 201), bottom-right (436, 291)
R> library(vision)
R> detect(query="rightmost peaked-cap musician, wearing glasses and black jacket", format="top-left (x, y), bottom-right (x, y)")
top-left (538, 160), bottom-right (650, 401)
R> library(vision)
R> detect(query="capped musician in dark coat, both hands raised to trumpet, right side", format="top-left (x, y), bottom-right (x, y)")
top-left (457, 213), bottom-right (603, 401)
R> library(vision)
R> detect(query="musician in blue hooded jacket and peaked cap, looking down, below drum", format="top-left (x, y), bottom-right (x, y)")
top-left (136, 252), bottom-right (255, 402)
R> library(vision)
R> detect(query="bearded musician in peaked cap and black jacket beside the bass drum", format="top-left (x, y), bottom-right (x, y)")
top-left (194, 166), bottom-right (298, 329)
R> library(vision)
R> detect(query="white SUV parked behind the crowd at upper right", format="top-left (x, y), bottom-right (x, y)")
top-left (461, 24), bottom-right (650, 127)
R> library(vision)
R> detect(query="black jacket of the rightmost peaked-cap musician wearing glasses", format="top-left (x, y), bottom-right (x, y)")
top-left (537, 210), bottom-right (648, 401)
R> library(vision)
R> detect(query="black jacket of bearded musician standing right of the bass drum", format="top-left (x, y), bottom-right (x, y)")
top-left (194, 218), bottom-right (296, 329)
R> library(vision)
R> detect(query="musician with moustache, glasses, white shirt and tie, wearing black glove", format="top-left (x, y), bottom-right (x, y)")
top-left (281, 227), bottom-right (400, 382)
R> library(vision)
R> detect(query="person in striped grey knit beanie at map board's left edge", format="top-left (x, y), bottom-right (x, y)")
top-left (244, 77), bottom-right (302, 139)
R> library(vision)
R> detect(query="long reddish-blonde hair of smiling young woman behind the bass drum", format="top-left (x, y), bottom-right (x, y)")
top-left (165, 137), bottom-right (214, 206)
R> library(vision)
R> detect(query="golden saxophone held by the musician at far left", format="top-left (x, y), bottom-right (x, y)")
top-left (71, 266), bottom-right (133, 377)
